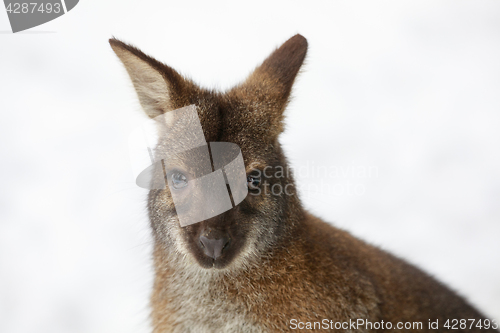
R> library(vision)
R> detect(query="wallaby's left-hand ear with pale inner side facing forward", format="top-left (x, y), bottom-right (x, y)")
top-left (109, 38), bottom-right (186, 118)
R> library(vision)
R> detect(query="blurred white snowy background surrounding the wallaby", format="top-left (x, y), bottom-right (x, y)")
top-left (0, 0), bottom-right (500, 333)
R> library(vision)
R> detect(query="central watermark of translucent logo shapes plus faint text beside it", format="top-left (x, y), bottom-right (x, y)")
top-left (129, 105), bottom-right (378, 226)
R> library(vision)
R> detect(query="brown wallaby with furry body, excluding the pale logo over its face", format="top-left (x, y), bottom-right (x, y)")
top-left (110, 35), bottom-right (498, 333)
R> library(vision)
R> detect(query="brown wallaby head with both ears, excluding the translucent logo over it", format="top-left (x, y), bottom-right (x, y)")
top-left (110, 35), bottom-right (307, 271)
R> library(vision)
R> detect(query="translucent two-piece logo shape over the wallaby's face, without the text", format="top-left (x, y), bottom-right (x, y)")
top-left (130, 105), bottom-right (248, 227)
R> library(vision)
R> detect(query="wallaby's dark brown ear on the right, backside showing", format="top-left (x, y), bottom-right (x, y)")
top-left (242, 34), bottom-right (307, 106)
